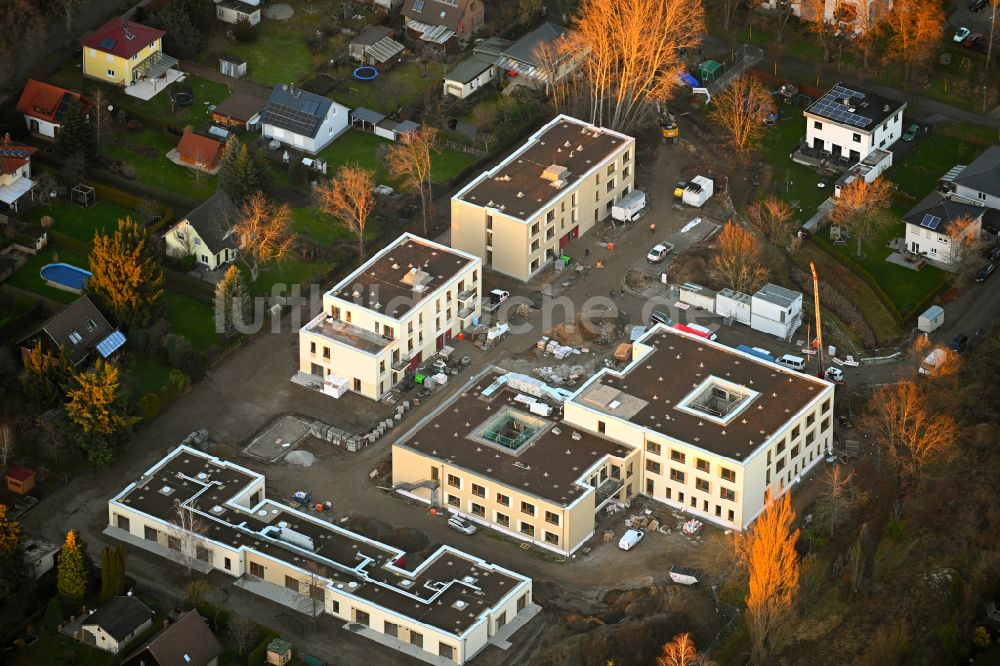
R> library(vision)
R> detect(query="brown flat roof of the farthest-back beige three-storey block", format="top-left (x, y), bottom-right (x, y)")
top-left (455, 115), bottom-right (632, 222)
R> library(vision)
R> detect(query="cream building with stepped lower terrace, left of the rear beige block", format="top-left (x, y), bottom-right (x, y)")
top-left (299, 234), bottom-right (482, 400)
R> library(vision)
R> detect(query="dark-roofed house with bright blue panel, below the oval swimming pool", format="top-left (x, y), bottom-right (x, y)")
top-left (19, 296), bottom-right (125, 366)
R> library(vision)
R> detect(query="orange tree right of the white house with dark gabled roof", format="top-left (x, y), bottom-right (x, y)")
top-left (230, 192), bottom-right (295, 280)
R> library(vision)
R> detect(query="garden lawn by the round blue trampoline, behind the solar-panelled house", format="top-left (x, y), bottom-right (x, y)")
top-left (330, 62), bottom-right (444, 114)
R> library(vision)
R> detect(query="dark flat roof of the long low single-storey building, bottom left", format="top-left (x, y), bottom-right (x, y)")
top-left (111, 446), bottom-right (528, 636)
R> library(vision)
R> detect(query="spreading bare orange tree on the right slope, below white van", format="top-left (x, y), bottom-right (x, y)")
top-left (861, 381), bottom-right (960, 486)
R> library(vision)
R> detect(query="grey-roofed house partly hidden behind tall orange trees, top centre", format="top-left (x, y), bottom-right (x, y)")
top-left (496, 22), bottom-right (578, 88)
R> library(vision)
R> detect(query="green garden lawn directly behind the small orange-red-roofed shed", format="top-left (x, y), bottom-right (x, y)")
top-left (104, 128), bottom-right (216, 201)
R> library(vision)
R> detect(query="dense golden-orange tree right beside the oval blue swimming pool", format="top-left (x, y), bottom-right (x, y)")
top-left (86, 217), bottom-right (163, 326)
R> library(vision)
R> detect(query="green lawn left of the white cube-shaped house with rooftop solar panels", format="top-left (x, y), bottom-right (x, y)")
top-left (759, 118), bottom-right (833, 222)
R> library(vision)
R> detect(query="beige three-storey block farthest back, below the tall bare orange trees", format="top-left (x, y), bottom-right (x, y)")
top-left (451, 115), bottom-right (635, 280)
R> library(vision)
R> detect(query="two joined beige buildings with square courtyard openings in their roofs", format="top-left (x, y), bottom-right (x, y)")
top-left (392, 326), bottom-right (834, 554)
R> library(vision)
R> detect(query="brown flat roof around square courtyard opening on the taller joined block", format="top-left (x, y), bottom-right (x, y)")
top-left (572, 326), bottom-right (833, 461)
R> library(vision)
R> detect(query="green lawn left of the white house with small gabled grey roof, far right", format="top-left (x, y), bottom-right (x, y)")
top-left (813, 215), bottom-right (951, 318)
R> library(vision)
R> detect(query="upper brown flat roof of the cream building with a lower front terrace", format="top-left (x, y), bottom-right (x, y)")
top-left (327, 234), bottom-right (477, 319)
